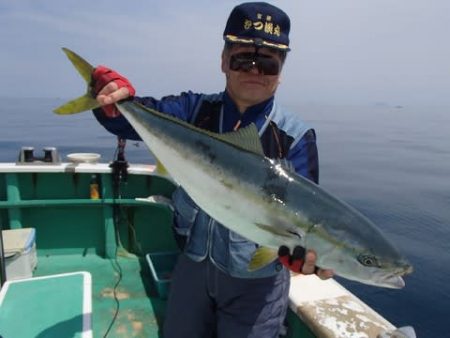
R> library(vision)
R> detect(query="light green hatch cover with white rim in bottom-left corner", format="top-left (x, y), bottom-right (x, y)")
top-left (0, 272), bottom-right (91, 338)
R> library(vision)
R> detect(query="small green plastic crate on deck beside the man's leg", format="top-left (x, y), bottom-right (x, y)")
top-left (145, 251), bottom-right (180, 299)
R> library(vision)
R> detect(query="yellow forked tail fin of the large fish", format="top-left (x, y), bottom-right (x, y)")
top-left (53, 48), bottom-right (100, 115)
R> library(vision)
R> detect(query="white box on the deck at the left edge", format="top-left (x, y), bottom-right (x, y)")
top-left (2, 228), bottom-right (37, 280)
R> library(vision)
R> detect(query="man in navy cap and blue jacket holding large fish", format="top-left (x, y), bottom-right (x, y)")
top-left (93, 2), bottom-right (332, 338)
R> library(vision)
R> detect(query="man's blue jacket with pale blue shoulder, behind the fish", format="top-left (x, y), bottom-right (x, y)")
top-left (94, 92), bottom-right (319, 278)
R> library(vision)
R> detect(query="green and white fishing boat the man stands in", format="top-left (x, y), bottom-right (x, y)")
top-left (0, 148), bottom-right (412, 338)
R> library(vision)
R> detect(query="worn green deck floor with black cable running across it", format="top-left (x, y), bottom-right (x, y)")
top-left (34, 254), bottom-right (165, 338)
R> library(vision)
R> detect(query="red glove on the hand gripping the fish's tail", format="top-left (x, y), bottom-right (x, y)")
top-left (92, 66), bottom-right (136, 117)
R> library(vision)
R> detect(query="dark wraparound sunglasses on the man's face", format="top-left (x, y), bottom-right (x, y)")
top-left (230, 53), bottom-right (281, 75)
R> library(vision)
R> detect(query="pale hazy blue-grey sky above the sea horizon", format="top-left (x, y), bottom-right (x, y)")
top-left (0, 0), bottom-right (450, 105)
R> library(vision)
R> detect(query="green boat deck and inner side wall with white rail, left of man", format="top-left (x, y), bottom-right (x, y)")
top-left (0, 163), bottom-right (176, 337)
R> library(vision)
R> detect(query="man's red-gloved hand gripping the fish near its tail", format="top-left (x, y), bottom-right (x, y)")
top-left (92, 66), bottom-right (136, 117)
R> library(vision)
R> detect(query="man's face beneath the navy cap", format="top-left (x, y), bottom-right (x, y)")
top-left (222, 45), bottom-right (282, 112)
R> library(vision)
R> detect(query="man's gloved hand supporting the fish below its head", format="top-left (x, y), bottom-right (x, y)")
top-left (278, 245), bottom-right (334, 279)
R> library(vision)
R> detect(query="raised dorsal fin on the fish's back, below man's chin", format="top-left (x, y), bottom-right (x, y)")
top-left (215, 123), bottom-right (264, 156)
